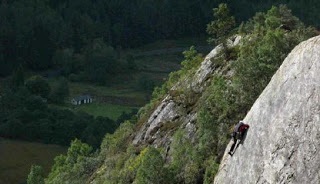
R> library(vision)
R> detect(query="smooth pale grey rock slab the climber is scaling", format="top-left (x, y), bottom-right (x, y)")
top-left (214, 36), bottom-right (320, 184)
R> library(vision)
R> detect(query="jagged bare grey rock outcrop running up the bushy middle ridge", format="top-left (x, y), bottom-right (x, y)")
top-left (133, 36), bottom-right (241, 151)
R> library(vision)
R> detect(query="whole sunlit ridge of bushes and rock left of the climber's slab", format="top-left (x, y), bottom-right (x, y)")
top-left (45, 6), bottom-right (315, 184)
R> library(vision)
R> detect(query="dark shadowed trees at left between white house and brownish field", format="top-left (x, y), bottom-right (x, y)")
top-left (0, 82), bottom-right (118, 148)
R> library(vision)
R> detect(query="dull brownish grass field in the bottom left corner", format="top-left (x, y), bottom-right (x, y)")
top-left (0, 138), bottom-right (67, 184)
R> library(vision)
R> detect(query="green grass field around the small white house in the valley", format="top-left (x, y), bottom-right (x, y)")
top-left (66, 83), bottom-right (147, 120)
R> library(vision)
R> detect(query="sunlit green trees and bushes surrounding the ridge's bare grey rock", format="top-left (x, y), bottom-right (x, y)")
top-left (34, 3), bottom-right (315, 183)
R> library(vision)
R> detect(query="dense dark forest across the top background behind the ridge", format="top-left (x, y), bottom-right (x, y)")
top-left (0, 0), bottom-right (320, 77)
